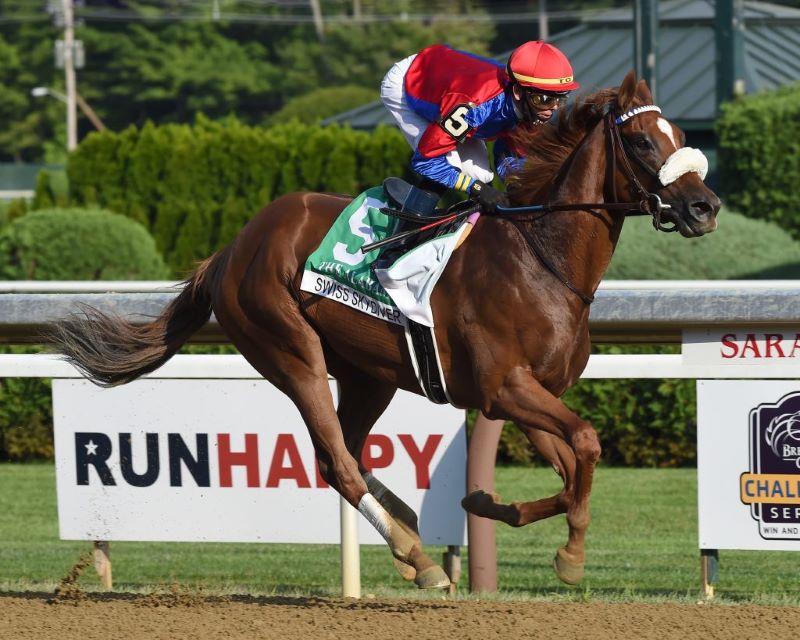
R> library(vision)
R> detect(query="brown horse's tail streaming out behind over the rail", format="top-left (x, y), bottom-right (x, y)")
top-left (44, 249), bottom-right (229, 387)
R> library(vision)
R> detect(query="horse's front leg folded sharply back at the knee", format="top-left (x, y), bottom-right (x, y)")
top-left (461, 427), bottom-right (575, 527)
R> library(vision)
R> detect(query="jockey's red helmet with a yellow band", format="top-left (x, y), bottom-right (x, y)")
top-left (508, 40), bottom-right (580, 92)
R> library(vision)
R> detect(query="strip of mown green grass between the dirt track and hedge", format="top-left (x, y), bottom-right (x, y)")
top-left (0, 464), bottom-right (800, 605)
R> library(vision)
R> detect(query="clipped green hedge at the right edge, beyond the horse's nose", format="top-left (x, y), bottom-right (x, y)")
top-left (716, 83), bottom-right (800, 238)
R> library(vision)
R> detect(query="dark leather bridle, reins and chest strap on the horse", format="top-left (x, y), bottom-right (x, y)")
top-left (496, 107), bottom-right (677, 305)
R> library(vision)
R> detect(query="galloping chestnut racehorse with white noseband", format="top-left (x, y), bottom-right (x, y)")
top-left (50, 72), bottom-right (720, 588)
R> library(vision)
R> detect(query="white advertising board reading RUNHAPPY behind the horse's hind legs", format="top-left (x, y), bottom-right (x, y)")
top-left (53, 379), bottom-right (466, 545)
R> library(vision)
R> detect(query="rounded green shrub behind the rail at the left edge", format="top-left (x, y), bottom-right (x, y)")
top-left (0, 209), bottom-right (167, 280)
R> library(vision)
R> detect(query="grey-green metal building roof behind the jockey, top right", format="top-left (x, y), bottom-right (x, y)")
top-left (323, 0), bottom-right (800, 129)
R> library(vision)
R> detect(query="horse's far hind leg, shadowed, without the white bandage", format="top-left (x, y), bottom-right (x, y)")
top-left (330, 369), bottom-right (450, 589)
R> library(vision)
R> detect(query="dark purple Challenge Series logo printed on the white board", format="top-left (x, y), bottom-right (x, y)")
top-left (739, 392), bottom-right (800, 540)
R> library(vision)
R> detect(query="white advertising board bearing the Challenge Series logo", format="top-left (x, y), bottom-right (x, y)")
top-left (697, 380), bottom-right (800, 550)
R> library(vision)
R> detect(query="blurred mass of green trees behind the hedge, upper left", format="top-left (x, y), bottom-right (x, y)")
top-left (0, 0), bottom-right (494, 161)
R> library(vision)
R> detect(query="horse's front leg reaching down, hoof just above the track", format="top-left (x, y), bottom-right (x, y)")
top-left (462, 368), bottom-right (600, 584)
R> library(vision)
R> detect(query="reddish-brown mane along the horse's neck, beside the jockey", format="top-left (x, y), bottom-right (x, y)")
top-left (507, 87), bottom-right (618, 204)
